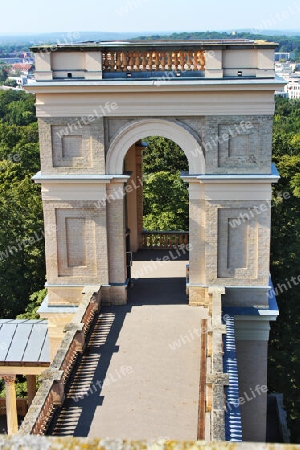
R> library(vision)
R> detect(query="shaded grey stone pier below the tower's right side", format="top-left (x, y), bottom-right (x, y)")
top-left (235, 316), bottom-right (270, 442)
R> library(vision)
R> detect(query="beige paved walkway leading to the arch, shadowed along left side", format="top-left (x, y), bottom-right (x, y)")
top-left (51, 253), bottom-right (206, 440)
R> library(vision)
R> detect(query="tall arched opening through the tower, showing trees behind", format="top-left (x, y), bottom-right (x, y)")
top-left (124, 136), bottom-right (189, 303)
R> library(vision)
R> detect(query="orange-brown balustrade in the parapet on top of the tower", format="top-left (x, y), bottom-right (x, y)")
top-left (102, 50), bottom-right (205, 72)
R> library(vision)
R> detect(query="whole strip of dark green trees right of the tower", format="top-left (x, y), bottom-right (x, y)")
top-left (268, 99), bottom-right (300, 442)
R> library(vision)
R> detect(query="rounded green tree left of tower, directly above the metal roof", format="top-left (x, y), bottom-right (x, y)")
top-left (0, 161), bottom-right (45, 317)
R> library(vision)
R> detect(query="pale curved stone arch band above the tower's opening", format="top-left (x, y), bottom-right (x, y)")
top-left (106, 118), bottom-right (205, 175)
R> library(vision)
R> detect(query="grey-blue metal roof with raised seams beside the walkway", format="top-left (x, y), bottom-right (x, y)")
top-left (0, 319), bottom-right (50, 365)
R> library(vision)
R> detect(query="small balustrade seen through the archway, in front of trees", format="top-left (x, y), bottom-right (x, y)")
top-left (142, 231), bottom-right (189, 250)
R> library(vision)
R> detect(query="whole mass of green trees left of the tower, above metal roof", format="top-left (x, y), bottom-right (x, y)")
top-left (0, 91), bottom-right (45, 318)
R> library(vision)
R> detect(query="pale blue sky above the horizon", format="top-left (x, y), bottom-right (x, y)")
top-left (0, 0), bottom-right (300, 35)
